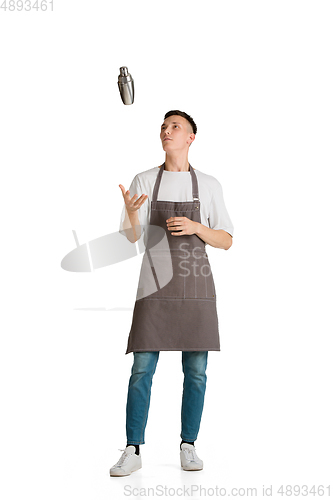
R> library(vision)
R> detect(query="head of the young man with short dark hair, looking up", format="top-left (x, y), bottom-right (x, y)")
top-left (160, 110), bottom-right (197, 152)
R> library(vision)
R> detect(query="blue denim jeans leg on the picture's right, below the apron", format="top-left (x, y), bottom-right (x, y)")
top-left (180, 351), bottom-right (208, 442)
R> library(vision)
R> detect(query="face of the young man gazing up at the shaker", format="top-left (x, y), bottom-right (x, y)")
top-left (160, 115), bottom-right (195, 152)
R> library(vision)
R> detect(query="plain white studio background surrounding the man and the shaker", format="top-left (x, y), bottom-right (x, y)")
top-left (0, 0), bottom-right (333, 500)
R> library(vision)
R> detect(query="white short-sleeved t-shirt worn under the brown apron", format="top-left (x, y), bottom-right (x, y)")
top-left (119, 167), bottom-right (234, 236)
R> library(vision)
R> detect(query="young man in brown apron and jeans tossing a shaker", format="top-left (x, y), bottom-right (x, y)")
top-left (110, 110), bottom-right (233, 476)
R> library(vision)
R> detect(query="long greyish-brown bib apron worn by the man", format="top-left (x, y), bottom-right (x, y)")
top-left (125, 163), bottom-right (220, 354)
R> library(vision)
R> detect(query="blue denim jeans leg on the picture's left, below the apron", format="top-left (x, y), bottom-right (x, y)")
top-left (126, 351), bottom-right (159, 444)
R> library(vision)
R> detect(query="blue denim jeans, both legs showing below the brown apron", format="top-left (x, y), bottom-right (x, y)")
top-left (126, 351), bottom-right (208, 444)
